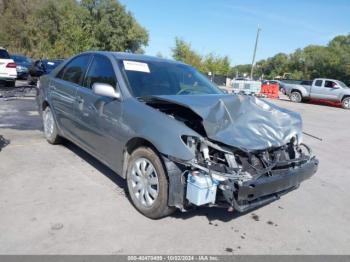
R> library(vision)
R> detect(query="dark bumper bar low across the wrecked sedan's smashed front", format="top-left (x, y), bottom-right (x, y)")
top-left (222, 158), bottom-right (318, 212)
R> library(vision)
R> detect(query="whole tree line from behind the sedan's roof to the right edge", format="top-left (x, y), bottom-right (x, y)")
top-left (172, 34), bottom-right (350, 85)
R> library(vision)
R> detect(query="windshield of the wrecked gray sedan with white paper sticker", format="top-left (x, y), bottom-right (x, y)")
top-left (118, 60), bottom-right (222, 97)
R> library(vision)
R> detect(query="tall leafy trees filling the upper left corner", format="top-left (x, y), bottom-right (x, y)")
top-left (0, 0), bottom-right (148, 58)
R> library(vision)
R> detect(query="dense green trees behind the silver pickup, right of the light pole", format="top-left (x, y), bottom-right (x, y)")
top-left (229, 34), bottom-right (350, 84)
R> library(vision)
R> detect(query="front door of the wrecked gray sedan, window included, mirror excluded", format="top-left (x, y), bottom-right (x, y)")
top-left (75, 54), bottom-right (123, 169)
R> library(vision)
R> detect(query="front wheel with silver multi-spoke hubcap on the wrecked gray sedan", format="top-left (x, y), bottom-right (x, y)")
top-left (126, 147), bottom-right (175, 219)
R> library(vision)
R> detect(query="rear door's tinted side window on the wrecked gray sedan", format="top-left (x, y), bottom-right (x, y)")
top-left (57, 55), bottom-right (90, 85)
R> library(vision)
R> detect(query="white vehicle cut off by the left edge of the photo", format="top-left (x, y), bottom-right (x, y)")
top-left (0, 47), bottom-right (17, 87)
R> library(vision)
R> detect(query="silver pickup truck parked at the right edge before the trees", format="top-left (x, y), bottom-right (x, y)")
top-left (284, 78), bottom-right (350, 109)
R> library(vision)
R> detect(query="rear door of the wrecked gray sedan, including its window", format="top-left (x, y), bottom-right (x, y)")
top-left (49, 54), bottom-right (91, 140)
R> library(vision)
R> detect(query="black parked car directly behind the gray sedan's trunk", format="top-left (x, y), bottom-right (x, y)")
top-left (28, 59), bottom-right (64, 85)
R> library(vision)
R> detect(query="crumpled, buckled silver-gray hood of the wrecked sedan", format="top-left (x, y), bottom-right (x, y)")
top-left (146, 95), bottom-right (302, 151)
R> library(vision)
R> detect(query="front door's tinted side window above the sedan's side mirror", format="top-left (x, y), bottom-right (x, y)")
top-left (83, 55), bottom-right (117, 89)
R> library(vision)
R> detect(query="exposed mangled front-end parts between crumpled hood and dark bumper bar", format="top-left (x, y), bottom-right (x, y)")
top-left (178, 137), bottom-right (315, 211)
